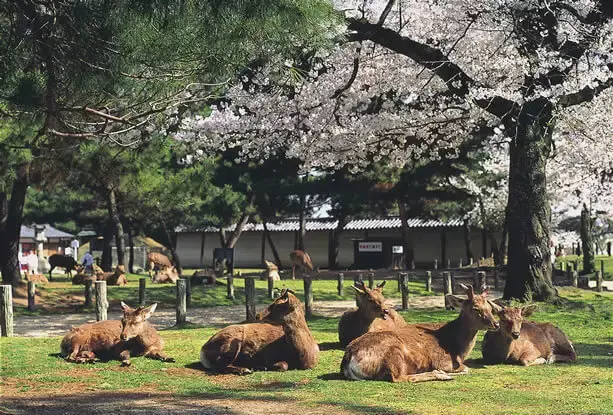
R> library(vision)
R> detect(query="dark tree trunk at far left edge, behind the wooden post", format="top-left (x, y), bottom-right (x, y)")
top-left (0, 163), bottom-right (30, 285)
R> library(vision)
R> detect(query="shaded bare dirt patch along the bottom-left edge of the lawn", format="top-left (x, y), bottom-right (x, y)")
top-left (0, 388), bottom-right (351, 415)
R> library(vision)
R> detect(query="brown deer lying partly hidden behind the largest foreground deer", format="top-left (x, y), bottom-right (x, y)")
top-left (338, 281), bottom-right (406, 347)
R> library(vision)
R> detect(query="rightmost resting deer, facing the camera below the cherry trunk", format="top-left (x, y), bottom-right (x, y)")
top-left (481, 304), bottom-right (577, 366)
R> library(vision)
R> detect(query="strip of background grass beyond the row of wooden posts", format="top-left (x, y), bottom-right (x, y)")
top-left (14, 274), bottom-right (431, 315)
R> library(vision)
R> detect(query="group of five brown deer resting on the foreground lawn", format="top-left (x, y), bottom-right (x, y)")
top-left (61, 249), bottom-right (577, 382)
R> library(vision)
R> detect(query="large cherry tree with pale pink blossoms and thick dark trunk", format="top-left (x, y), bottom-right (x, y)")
top-left (178, 0), bottom-right (613, 300)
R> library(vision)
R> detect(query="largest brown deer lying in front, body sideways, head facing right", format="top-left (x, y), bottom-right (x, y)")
top-left (341, 284), bottom-right (500, 382)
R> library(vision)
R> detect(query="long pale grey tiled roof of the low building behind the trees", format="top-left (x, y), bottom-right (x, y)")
top-left (176, 217), bottom-right (462, 232)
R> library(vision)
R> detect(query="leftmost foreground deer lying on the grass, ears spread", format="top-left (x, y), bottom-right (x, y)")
top-left (60, 301), bottom-right (174, 366)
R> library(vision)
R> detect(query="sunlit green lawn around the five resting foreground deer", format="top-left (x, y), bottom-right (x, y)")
top-left (0, 285), bottom-right (613, 415)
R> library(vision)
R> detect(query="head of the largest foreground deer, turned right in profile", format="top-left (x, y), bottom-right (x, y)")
top-left (447, 284), bottom-right (502, 330)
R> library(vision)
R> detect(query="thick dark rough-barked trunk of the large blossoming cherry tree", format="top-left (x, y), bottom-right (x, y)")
top-left (504, 99), bottom-right (557, 301)
